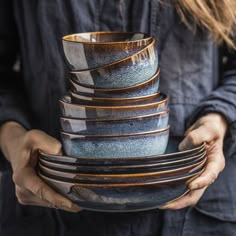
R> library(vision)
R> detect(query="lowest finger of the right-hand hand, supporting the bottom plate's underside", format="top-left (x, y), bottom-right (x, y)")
top-left (161, 188), bottom-right (206, 210)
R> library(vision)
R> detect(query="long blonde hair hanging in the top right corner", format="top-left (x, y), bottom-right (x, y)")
top-left (175, 0), bottom-right (236, 49)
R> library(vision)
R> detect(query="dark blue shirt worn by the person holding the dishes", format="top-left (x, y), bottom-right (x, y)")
top-left (0, 0), bottom-right (236, 235)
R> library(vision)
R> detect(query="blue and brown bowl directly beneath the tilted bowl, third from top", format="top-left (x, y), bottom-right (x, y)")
top-left (70, 69), bottom-right (160, 98)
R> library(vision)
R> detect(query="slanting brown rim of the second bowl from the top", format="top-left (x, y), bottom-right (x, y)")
top-left (70, 38), bottom-right (158, 75)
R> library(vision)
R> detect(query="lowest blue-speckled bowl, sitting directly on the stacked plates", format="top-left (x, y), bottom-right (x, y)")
top-left (61, 126), bottom-right (170, 158)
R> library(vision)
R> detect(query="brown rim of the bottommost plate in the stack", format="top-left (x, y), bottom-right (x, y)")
top-left (38, 168), bottom-right (204, 188)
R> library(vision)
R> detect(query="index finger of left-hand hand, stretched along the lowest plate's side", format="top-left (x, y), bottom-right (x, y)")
top-left (15, 168), bottom-right (80, 211)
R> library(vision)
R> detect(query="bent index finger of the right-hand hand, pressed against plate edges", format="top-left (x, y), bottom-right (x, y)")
top-left (189, 154), bottom-right (225, 190)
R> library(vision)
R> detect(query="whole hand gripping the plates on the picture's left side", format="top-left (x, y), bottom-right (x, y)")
top-left (0, 122), bottom-right (80, 212)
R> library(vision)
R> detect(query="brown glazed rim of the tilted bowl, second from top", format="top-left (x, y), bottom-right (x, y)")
top-left (70, 39), bottom-right (156, 74)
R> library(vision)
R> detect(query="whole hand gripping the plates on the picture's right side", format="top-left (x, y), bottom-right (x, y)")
top-left (161, 113), bottom-right (227, 210)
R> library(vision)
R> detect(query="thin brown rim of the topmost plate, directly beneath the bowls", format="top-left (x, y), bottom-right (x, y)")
top-left (38, 143), bottom-right (206, 163)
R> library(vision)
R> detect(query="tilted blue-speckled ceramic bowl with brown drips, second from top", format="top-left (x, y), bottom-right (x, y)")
top-left (71, 39), bottom-right (158, 89)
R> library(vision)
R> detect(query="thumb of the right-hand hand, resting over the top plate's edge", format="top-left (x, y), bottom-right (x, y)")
top-left (179, 126), bottom-right (215, 150)
